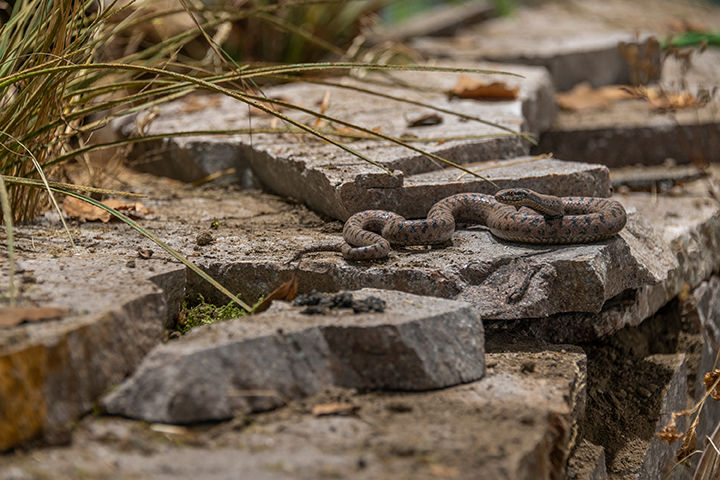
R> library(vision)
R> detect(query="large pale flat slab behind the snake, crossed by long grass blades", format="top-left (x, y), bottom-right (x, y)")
top-left (118, 64), bottom-right (556, 220)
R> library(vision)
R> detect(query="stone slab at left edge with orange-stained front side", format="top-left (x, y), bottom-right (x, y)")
top-left (0, 256), bottom-right (185, 451)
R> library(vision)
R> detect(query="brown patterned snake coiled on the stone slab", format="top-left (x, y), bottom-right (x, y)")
top-left (293, 188), bottom-right (627, 260)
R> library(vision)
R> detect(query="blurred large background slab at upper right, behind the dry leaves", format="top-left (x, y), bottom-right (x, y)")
top-left (411, 3), bottom-right (660, 90)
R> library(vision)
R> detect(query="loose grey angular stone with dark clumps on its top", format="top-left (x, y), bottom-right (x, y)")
top-left (103, 289), bottom-right (485, 423)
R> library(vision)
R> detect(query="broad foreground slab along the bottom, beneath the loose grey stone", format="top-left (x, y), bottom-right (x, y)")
top-left (0, 347), bottom-right (586, 480)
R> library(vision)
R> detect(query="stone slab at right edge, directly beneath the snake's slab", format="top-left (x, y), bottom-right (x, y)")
top-left (486, 193), bottom-right (720, 343)
